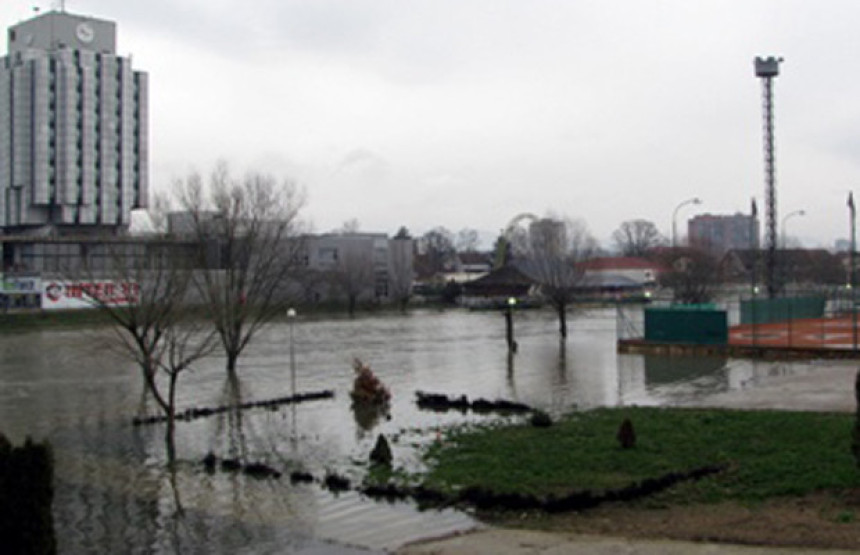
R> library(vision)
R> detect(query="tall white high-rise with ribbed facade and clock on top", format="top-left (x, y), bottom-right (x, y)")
top-left (0, 11), bottom-right (149, 234)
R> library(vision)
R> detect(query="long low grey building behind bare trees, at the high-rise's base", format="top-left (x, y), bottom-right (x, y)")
top-left (0, 228), bottom-right (414, 311)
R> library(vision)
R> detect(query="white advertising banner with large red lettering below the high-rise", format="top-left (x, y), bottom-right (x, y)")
top-left (42, 280), bottom-right (140, 310)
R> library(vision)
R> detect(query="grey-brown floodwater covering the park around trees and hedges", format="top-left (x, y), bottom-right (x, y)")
top-left (0, 309), bottom-right (844, 554)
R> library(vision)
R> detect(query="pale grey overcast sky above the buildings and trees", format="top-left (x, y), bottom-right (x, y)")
top-left (0, 0), bottom-right (860, 247)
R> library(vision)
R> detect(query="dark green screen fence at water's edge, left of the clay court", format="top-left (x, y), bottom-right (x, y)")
top-left (645, 305), bottom-right (729, 345)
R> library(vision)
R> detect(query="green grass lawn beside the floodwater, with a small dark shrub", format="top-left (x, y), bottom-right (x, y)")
top-left (425, 408), bottom-right (860, 502)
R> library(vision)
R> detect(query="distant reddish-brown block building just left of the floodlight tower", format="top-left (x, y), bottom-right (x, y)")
top-left (687, 213), bottom-right (759, 253)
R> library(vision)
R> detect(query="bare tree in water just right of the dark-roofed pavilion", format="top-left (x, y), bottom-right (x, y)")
top-left (526, 218), bottom-right (597, 339)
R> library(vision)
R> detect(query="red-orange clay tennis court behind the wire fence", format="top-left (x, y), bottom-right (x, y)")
top-left (729, 316), bottom-right (860, 349)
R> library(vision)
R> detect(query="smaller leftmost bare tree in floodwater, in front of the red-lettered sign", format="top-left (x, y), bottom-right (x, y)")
top-left (73, 239), bottom-right (217, 462)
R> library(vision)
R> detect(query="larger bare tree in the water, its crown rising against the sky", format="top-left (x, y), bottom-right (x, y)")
top-left (176, 162), bottom-right (304, 373)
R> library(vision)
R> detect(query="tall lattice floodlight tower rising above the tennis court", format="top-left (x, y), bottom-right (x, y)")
top-left (755, 56), bottom-right (782, 299)
